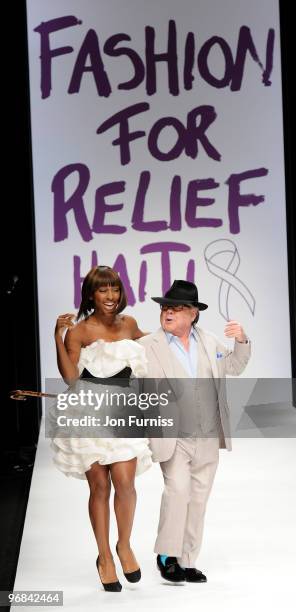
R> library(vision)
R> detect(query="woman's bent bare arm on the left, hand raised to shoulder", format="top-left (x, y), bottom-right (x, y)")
top-left (55, 313), bottom-right (82, 384)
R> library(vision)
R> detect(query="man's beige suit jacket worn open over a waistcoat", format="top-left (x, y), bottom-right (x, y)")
top-left (138, 326), bottom-right (251, 462)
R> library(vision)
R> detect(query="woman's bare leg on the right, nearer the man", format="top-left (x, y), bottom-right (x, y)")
top-left (110, 457), bottom-right (139, 572)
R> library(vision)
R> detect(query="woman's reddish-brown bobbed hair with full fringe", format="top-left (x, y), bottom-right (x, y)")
top-left (77, 266), bottom-right (127, 321)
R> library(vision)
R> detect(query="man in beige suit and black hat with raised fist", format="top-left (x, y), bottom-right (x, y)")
top-left (139, 280), bottom-right (250, 583)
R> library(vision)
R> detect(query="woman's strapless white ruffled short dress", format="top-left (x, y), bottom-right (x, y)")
top-left (50, 340), bottom-right (152, 480)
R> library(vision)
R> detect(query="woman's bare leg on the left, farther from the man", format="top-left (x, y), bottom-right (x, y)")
top-left (85, 463), bottom-right (118, 582)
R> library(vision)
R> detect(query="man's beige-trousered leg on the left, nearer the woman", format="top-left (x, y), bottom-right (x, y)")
top-left (154, 439), bottom-right (191, 557)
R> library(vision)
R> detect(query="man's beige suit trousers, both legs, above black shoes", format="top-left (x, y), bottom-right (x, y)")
top-left (154, 437), bottom-right (219, 567)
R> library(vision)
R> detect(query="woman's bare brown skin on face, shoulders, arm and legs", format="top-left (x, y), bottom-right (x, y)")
top-left (55, 285), bottom-right (145, 583)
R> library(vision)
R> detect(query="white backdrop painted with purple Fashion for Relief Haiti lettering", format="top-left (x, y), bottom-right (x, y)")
top-left (27, 0), bottom-right (291, 379)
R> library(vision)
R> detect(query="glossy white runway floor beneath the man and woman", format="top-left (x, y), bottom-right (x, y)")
top-left (11, 428), bottom-right (296, 612)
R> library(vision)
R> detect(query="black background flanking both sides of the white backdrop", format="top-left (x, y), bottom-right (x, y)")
top-left (0, 0), bottom-right (296, 590)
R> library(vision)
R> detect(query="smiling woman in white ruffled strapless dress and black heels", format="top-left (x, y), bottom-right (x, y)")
top-left (51, 266), bottom-right (152, 591)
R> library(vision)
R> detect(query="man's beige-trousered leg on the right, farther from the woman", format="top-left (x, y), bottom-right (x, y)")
top-left (177, 438), bottom-right (219, 568)
